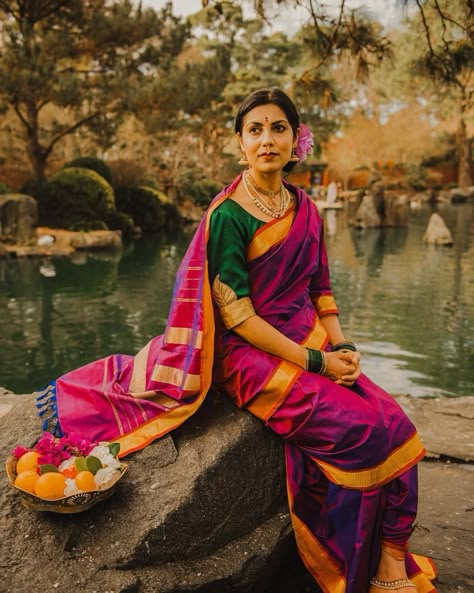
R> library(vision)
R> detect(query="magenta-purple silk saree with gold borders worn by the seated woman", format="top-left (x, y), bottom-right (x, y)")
top-left (38, 177), bottom-right (435, 593)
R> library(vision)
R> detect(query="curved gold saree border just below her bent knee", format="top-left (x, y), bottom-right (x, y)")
top-left (313, 433), bottom-right (426, 490)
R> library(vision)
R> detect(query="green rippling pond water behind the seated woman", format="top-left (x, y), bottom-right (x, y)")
top-left (0, 204), bottom-right (474, 397)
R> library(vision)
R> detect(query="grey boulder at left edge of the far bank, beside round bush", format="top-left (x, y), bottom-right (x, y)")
top-left (0, 194), bottom-right (38, 244)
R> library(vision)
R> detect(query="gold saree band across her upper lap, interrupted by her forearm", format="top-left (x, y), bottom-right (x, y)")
top-left (246, 317), bottom-right (328, 420)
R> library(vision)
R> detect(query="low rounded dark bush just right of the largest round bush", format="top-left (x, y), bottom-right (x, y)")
top-left (115, 186), bottom-right (180, 232)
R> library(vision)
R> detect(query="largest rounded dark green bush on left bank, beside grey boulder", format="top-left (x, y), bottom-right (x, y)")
top-left (23, 167), bottom-right (112, 230)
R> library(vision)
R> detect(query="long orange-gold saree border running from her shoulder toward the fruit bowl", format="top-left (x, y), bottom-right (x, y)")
top-left (114, 193), bottom-right (229, 458)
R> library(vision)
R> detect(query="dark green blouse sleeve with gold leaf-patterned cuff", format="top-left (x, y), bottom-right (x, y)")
top-left (207, 208), bottom-right (255, 329)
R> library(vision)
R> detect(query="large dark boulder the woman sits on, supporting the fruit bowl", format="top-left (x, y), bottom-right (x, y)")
top-left (0, 395), bottom-right (295, 593)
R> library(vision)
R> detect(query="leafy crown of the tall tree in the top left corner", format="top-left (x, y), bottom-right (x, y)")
top-left (0, 0), bottom-right (187, 179)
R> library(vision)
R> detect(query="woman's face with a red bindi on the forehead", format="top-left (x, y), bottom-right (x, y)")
top-left (239, 103), bottom-right (297, 173)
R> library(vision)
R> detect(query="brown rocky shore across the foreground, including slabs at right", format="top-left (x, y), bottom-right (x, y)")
top-left (0, 389), bottom-right (474, 593)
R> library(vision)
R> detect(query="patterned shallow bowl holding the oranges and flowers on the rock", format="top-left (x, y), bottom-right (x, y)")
top-left (6, 455), bottom-right (128, 513)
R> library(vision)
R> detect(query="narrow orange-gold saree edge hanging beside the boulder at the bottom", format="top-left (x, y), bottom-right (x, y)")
top-left (287, 482), bottom-right (347, 593)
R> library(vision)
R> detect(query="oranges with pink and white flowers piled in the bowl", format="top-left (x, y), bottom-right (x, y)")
top-left (12, 432), bottom-right (121, 500)
